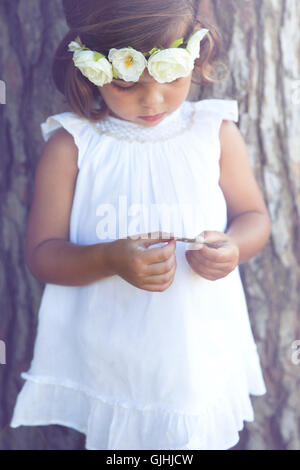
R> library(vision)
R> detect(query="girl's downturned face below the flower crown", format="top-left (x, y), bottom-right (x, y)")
top-left (98, 68), bottom-right (192, 127)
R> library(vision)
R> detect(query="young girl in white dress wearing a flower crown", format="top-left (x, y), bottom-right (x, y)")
top-left (11, 0), bottom-right (270, 450)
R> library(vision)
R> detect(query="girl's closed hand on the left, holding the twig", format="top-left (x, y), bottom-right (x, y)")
top-left (112, 232), bottom-right (177, 292)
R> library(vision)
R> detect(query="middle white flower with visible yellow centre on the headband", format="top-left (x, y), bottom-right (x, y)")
top-left (108, 47), bottom-right (147, 82)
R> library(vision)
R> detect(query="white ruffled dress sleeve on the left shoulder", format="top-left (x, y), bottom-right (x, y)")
top-left (40, 112), bottom-right (89, 169)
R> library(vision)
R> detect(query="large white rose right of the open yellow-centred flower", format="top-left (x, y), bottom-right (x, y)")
top-left (148, 48), bottom-right (194, 83)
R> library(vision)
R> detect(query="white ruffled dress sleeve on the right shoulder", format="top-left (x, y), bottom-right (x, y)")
top-left (190, 98), bottom-right (239, 122)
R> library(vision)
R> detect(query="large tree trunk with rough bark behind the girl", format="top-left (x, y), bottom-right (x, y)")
top-left (0, 0), bottom-right (300, 450)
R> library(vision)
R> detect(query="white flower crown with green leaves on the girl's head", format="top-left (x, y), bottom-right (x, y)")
top-left (68, 28), bottom-right (209, 86)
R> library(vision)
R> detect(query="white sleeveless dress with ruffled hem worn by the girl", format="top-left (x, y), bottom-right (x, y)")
top-left (10, 99), bottom-right (266, 450)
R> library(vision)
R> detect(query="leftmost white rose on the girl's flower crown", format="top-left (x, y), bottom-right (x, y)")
top-left (73, 50), bottom-right (113, 86)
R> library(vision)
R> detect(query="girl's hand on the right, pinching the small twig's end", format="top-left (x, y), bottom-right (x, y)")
top-left (185, 231), bottom-right (239, 281)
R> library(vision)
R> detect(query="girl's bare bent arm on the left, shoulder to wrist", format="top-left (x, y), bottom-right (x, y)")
top-left (25, 129), bottom-right (114, 286)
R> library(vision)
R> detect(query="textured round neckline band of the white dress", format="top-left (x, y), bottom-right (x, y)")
top-left (90, 101), bottom-right (195, 143)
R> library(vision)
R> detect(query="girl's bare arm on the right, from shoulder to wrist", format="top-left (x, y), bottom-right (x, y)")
top-left (219, 120), bottom-right (271, 264)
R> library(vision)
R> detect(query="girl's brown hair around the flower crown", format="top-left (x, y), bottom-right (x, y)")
top-left (52, 0), bottom-right (227, 121)
